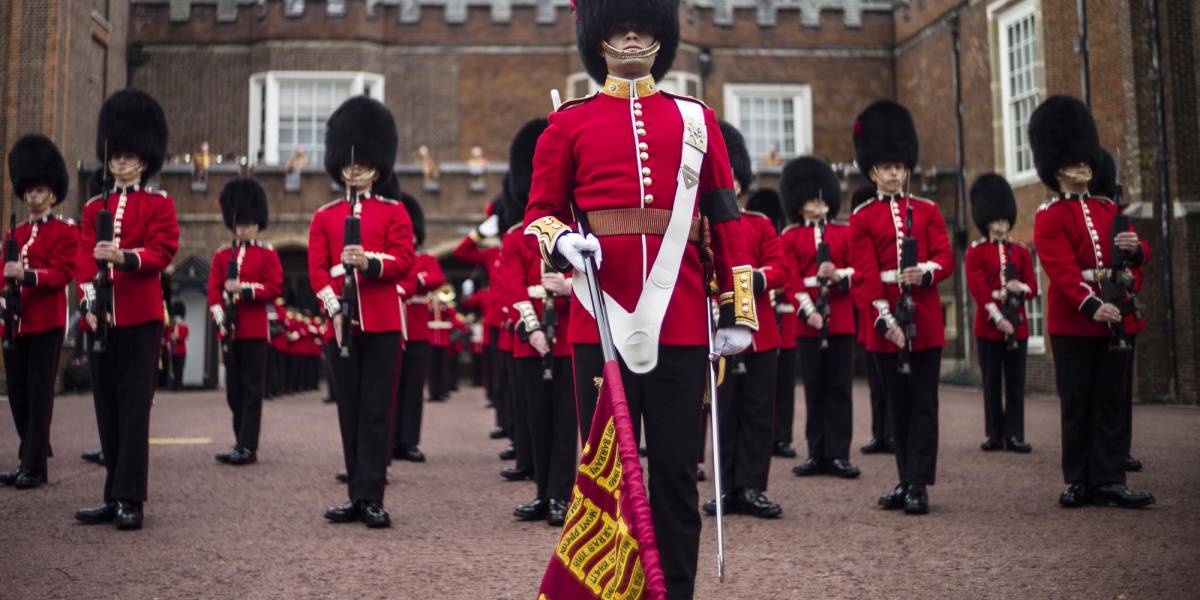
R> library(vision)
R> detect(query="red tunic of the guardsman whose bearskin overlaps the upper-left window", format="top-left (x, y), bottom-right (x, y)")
top-left (308, 193), bottom-right (415, 334)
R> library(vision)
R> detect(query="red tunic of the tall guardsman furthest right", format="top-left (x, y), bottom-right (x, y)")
top-left (1033, 194), bottom-right (1150, 337)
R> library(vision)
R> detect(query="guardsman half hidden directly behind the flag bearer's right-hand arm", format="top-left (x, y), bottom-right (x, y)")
top-left (703, 121), bottom-right (788, 518)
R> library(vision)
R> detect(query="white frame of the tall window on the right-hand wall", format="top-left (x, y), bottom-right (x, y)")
top-left (988, 0), bottom-right (1045, 187)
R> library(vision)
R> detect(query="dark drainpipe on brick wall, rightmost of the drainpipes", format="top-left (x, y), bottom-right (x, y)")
top-left (1146, 0), bottom-right (1180, 402)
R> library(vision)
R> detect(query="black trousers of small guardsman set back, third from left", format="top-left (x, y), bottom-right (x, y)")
top-left (224, 340), bottom-right (266, 452)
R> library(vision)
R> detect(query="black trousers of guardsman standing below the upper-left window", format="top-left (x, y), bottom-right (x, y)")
top-left (329, 331), bottom-right (400, 502)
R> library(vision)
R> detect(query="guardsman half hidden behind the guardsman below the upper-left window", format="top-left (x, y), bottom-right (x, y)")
top-left (391, 190), bottom-right (446, 462)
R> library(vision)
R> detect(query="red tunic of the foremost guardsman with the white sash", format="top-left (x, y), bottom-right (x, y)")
top-left (524, 92), bottom-right (750, 346)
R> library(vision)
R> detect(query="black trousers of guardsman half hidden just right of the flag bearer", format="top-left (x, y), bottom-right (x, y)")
top-left (716, 350), bottom-right (779, 493)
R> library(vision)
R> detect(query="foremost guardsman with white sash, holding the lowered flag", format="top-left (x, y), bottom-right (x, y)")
top-left (526, 0), bottom-right (758, 599)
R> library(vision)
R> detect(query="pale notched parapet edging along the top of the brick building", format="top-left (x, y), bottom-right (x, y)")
top-left (132, 0), bottom-right (906, 28)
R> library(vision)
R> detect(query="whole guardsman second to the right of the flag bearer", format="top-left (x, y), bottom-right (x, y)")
top-left (779, 156), bottom-right (859, 479)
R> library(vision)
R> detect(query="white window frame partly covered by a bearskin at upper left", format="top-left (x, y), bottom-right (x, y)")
top-left (247, 71), bottom-right (384, 164)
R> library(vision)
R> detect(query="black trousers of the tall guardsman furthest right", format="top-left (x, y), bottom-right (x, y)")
top-left (1050, 336), bottom-right (1129, 487)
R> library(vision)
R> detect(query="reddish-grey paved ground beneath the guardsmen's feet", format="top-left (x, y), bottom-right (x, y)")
top-left (0, 388), bottom-right (1200, 600)
